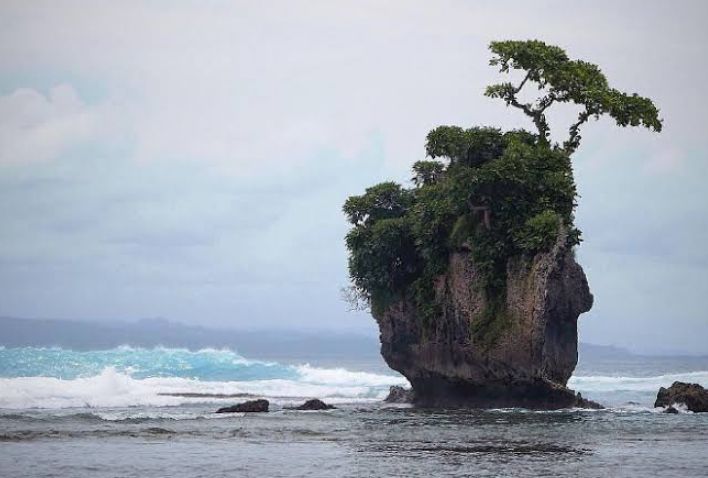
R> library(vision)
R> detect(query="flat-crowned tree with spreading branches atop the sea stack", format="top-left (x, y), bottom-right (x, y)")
top-left (485, 40), bottom-right (662, 153)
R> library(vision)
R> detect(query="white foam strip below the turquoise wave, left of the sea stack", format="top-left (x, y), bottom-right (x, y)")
top-left (0, 365), bottom-right (407, 409)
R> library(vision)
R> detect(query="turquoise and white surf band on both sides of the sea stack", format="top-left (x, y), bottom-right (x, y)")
top-left (0, 346), bottom-right (708, 409)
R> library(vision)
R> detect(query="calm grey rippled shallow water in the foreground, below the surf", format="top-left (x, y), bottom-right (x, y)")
top-left (0, 403), bottom-right (708, 478)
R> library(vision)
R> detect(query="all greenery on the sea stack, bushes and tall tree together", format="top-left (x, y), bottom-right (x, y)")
top-left (343, 37), bottom-right (662, 346)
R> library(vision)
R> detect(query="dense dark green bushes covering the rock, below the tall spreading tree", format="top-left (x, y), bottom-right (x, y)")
top-left (344, 128), bottom-right (579, 317)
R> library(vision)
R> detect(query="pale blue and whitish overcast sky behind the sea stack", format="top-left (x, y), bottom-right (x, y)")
top-left (0, 0), bottom-right (708, 353)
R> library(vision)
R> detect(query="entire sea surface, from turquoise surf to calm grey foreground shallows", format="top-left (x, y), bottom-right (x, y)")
top-left (0, 346), bottom-right (708, 478)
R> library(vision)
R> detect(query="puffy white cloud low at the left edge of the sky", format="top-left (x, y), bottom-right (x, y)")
top-left (0, 85), bottom-right (98, 164)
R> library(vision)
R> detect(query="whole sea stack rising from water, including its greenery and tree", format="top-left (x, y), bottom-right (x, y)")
top-left (343, 40), bottom-right (662, 409)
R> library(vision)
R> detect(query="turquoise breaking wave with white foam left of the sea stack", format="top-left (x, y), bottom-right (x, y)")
top-left (0, 347), bottom-right (407, 409)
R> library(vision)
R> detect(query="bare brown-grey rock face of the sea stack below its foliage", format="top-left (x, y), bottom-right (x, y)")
top-left (374, 234), bottom-right (593, 409)
